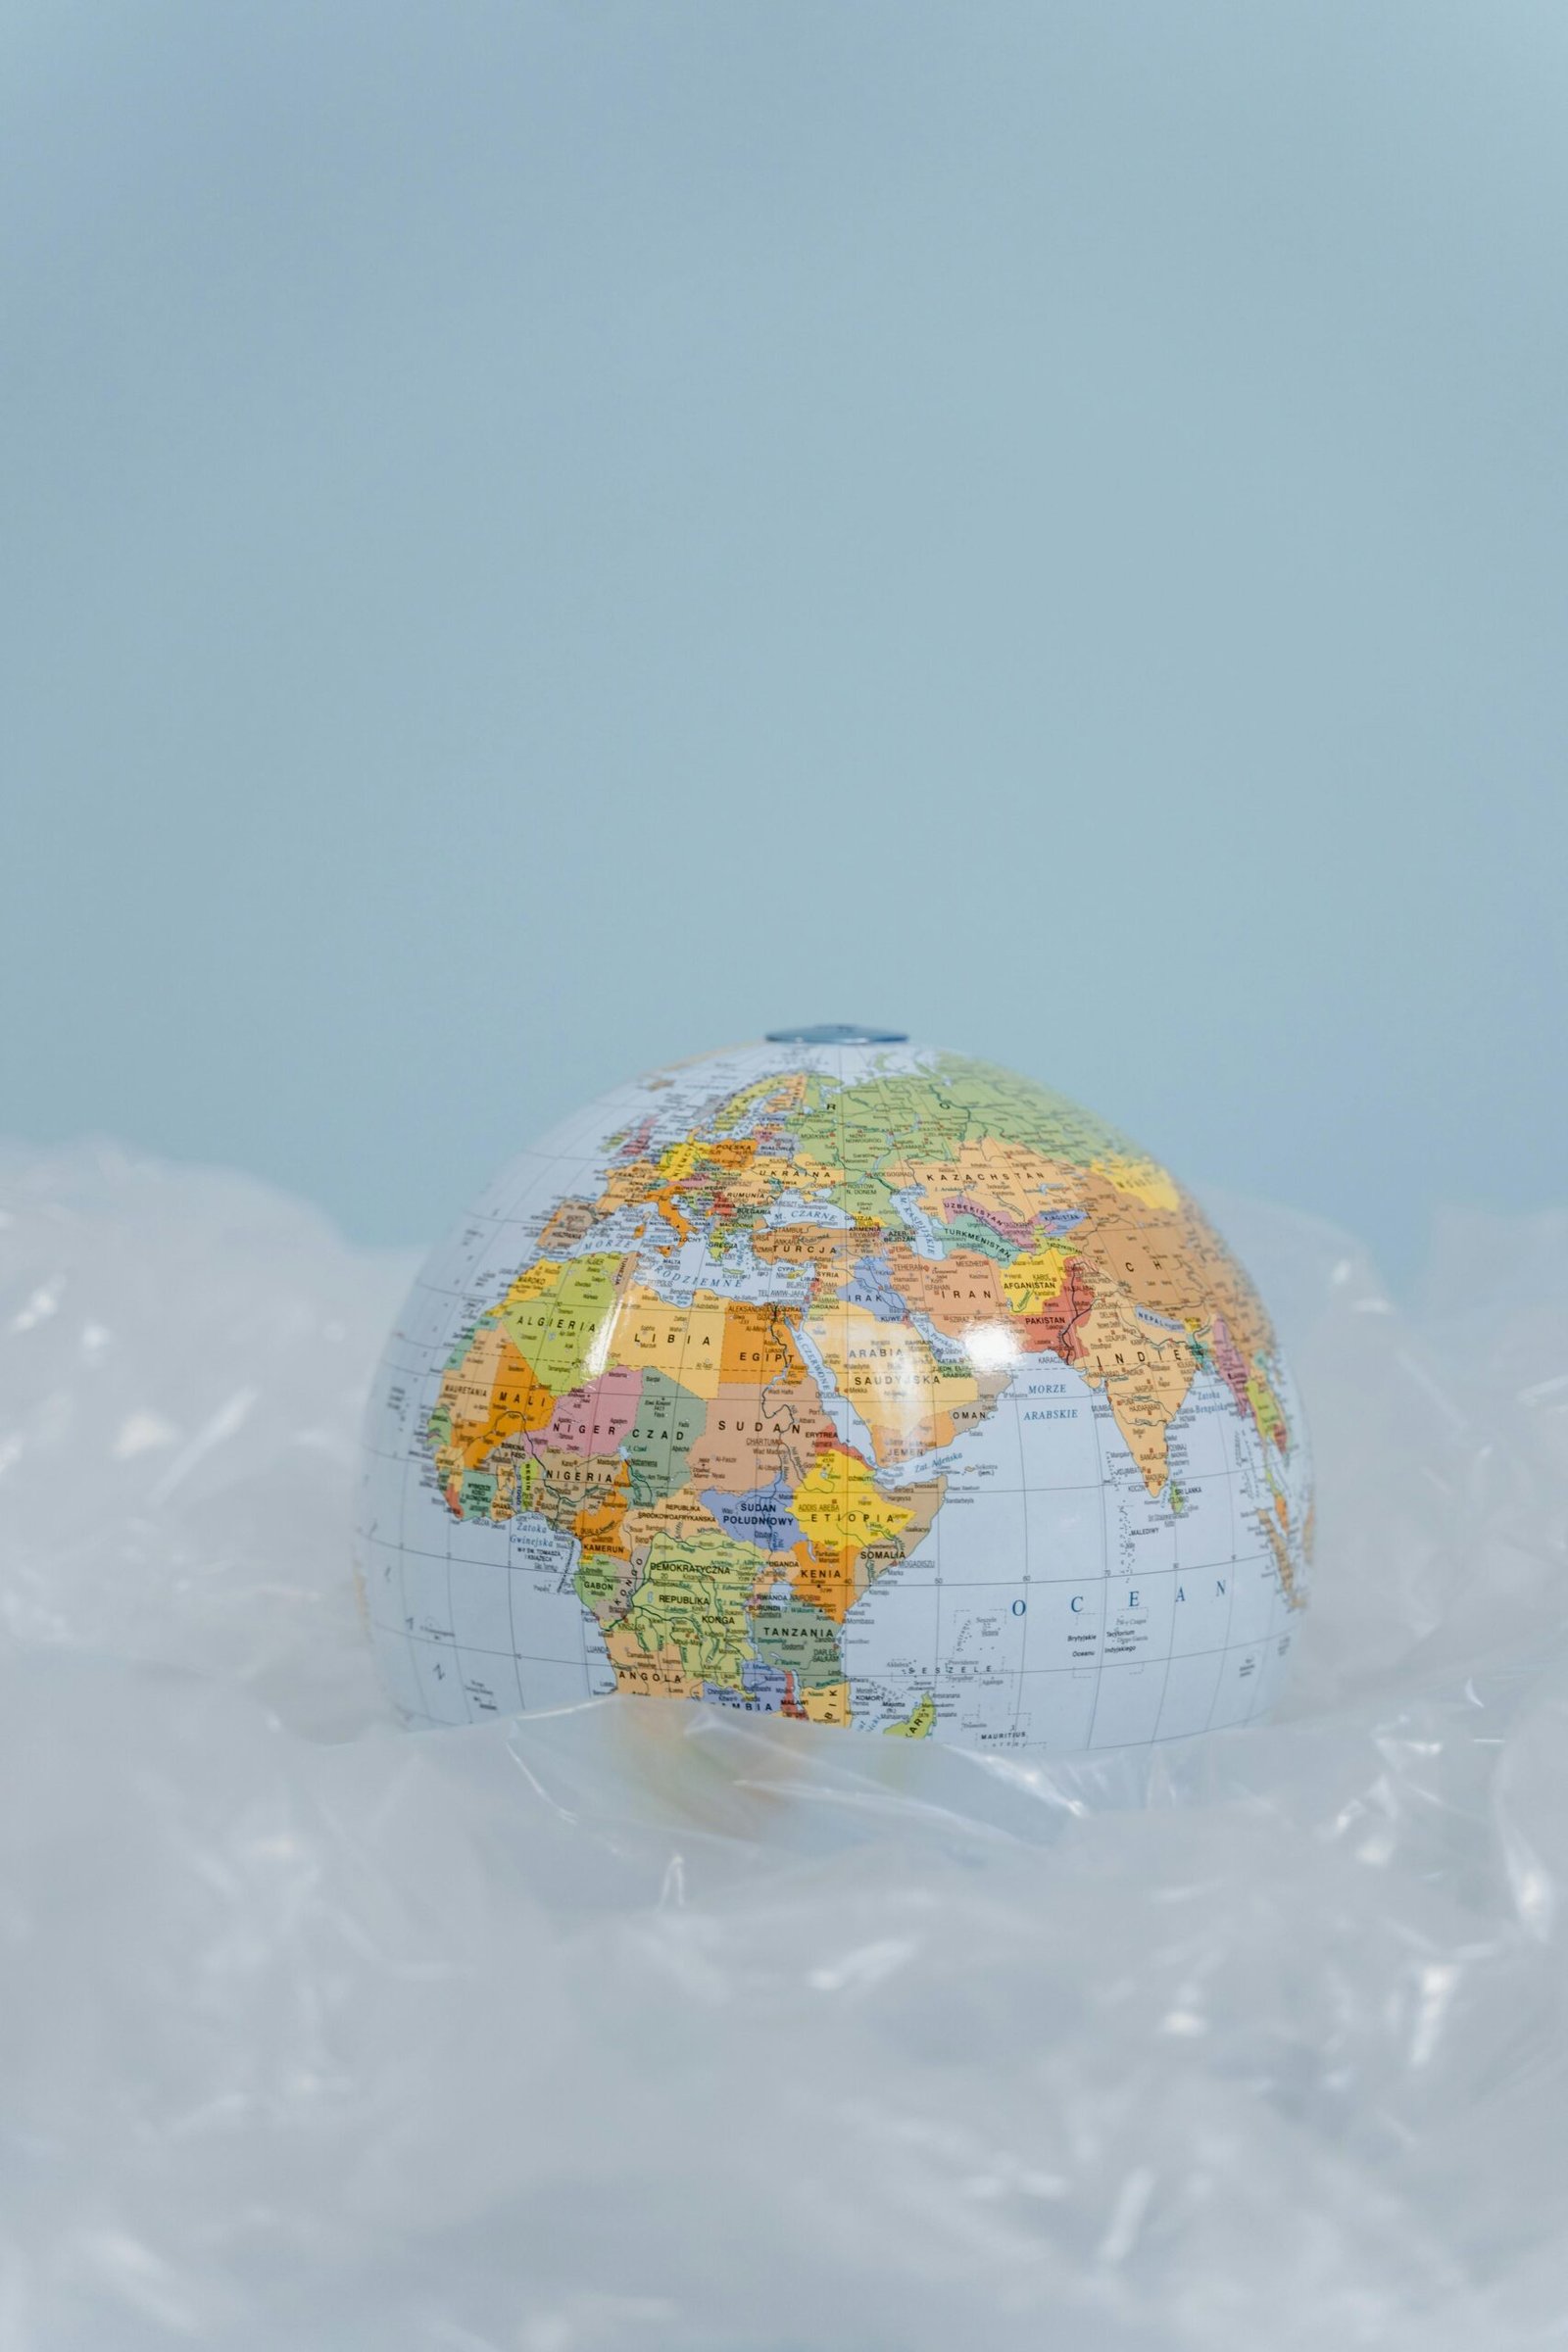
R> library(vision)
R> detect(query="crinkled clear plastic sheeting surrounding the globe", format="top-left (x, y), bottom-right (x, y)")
top-left (0, 1151), bottom-right (1568, 2352)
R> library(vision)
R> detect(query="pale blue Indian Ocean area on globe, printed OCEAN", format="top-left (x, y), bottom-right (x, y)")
top-left (841, 1357), bottom-right (1304, 1750)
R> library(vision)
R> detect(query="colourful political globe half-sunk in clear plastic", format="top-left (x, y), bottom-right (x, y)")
top-left (358, 1028), bottom-right (1312, 1750)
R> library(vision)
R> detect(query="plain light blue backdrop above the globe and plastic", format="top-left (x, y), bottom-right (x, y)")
top-left (0, 0), bottom-right (1568, 1272)
